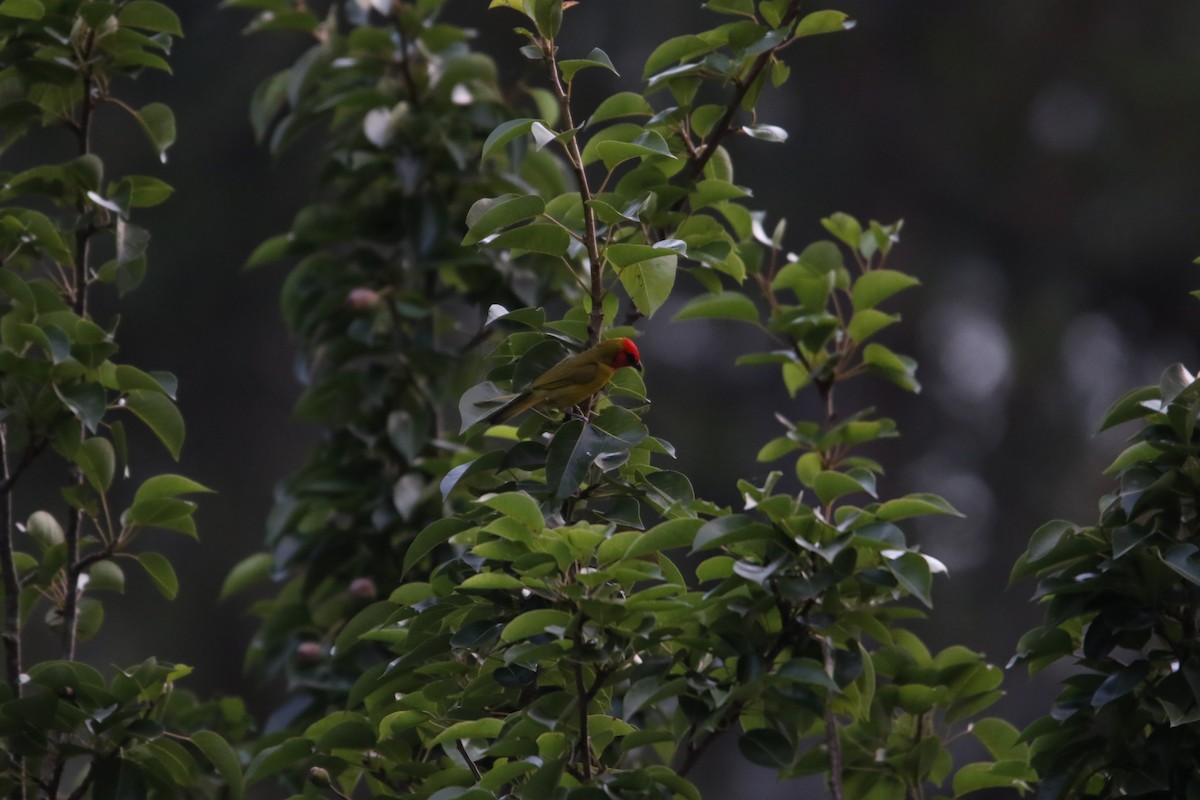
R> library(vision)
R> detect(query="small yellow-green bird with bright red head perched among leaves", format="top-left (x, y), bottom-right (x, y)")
top-left (484, 338), bottom-right (642, 425)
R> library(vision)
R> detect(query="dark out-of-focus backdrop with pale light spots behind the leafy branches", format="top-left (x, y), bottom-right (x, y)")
top-left (9, 0), bottom-right (1200, 796)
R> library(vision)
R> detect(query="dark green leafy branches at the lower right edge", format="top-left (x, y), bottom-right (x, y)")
top-left (1013, 365), bottom-right (1200, 798)
